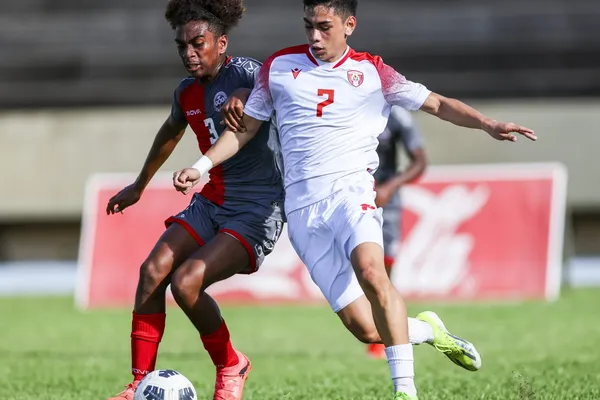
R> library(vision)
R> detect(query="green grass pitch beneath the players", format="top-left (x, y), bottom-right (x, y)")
top-left (0, 290), bottom-right (600, 400)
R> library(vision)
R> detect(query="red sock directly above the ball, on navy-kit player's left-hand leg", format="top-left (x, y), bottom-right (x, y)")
top-left (131, 313), bottom-right (166, 381)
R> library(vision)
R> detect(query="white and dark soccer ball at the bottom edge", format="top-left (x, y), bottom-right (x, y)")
top-left (133, 369), bottom-right (198, 400)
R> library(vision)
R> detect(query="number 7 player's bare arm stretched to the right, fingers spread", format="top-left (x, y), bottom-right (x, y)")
top-left (421, 93), bottom-right (537, 142)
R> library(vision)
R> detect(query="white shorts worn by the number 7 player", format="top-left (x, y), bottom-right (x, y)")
top-left (287, 172), bottom-right (383, 313)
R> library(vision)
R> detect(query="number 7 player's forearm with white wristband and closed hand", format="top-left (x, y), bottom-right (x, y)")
top-left (173, 114), bottom-right (263, 194)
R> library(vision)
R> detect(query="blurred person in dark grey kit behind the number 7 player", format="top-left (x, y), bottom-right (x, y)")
top-left (367, 107), bottom-right (427, 359)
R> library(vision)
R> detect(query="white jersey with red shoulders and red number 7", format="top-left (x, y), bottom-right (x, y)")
top-left (244, 45), bottom-right (431, 213)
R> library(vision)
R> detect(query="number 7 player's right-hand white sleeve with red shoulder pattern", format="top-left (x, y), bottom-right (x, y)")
top-left (375, 58), bottom-right (431, 111)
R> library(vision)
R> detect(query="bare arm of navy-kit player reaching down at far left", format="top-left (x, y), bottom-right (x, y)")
top-left (106, 116), bottom-right (187, 214)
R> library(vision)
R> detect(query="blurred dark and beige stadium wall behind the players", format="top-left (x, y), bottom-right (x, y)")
top-left (0, 0), bottom-right (600, 288)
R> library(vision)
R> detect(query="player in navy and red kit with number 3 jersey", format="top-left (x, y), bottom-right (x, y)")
top-left (106, 0), bottom-right (284, 400)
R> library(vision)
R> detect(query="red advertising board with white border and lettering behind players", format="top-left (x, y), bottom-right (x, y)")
top-left (76, 164), bottom-right (567, 309)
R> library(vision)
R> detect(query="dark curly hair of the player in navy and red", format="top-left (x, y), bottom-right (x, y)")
top-left (165, 0), bottom-right (246, 36)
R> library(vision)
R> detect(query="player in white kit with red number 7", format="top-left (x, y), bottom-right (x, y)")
top-left (173, 0), bottom-right (536, 400)
